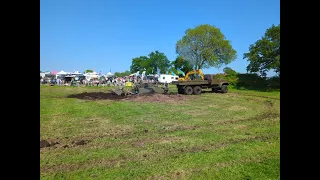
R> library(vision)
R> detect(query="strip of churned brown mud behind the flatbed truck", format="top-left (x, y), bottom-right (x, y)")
top-left (68, 92), bottom-right (186, 102)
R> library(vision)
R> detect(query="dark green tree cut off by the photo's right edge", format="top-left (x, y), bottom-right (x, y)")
top-left (243, 24), bottom-right (280, 76)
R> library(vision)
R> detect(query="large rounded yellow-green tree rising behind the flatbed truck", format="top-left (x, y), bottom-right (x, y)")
top-left (176, 24), bottom-right (237, 69)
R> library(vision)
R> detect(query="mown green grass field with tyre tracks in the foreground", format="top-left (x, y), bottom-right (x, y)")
top-left (40, 86), bottom-right (280, 180)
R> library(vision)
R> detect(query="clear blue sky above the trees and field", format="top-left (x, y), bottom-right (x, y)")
top-left (40, 0), bottom-right (280, 75)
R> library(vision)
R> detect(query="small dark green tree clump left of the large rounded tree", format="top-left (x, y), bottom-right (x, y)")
top-left (130, 51), bottom-right (171, 74)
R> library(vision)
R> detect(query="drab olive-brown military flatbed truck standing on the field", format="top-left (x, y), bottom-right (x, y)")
top-left (172, 74), bottom-right (229, 95)
